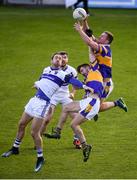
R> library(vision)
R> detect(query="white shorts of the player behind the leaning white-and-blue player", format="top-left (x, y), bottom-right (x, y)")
top-left (50, 93), bottom-right (73, 106)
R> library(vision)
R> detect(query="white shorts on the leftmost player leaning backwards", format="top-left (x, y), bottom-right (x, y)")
top-left (25, 96), bottom-right (50, 118)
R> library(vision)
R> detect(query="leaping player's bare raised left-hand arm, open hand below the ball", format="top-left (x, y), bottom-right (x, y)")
top-left (74, 23), bottom-right (99, 51)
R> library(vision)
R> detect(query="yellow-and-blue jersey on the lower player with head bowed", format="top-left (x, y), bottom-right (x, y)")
top-left (85, 70), bottom-right (103, 98)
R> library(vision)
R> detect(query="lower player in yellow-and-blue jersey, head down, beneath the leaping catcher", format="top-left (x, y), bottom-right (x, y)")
top-left (63, 65), bottom-right (103, 162)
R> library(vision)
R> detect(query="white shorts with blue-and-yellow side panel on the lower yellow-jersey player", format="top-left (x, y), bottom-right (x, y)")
top-left (79, 97), bottom-right (100, 120)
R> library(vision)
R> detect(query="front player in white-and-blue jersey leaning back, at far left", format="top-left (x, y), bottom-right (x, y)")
top-left (2, 53), bottom-right (92, 172)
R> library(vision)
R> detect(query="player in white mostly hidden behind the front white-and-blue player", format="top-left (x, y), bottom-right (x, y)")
top-left (40, 51), bottom-right (81, 149)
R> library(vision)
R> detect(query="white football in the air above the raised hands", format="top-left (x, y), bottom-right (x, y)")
top-left (73, 8), bottom-right (87, 21)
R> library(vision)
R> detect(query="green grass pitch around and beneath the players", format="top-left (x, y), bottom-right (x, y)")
top-left (0, 7), bottom-right (137, 179)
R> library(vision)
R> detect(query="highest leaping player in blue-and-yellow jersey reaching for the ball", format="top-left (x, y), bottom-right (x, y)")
top-left (74, 20), bottom-right (128, 112)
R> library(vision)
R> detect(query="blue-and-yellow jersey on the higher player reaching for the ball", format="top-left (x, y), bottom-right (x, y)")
top-left (96, 44), bottom-right (112, 78)
